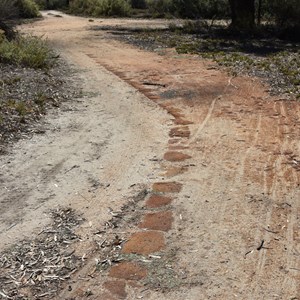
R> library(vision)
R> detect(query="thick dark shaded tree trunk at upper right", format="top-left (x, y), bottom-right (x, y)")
top-left (229, 0), bottom-right (255, 31)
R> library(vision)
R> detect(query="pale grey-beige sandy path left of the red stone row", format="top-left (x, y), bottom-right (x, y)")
top-left (0, 13), bottom-right (168, 248)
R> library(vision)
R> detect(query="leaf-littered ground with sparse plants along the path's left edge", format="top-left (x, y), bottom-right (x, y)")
top-left (0, 61), bottom-right (77, 151)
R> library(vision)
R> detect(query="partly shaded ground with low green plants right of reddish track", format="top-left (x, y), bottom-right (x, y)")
top-left (113, 21), bottom-right (300, 98)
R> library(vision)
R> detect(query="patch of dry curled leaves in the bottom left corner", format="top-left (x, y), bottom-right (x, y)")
top-left (0, 208), bottom-right (83, 300)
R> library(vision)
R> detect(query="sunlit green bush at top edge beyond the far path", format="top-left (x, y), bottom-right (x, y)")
top-left (70, 0), bottom-right (131, 17)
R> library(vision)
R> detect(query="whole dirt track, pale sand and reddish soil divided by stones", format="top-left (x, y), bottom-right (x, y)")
top-left (0, 10), bottom-right (300, 299)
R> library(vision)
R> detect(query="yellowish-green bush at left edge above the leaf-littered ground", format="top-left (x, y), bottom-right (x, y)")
top-left (0, 36), bottom-right (51, 69)
